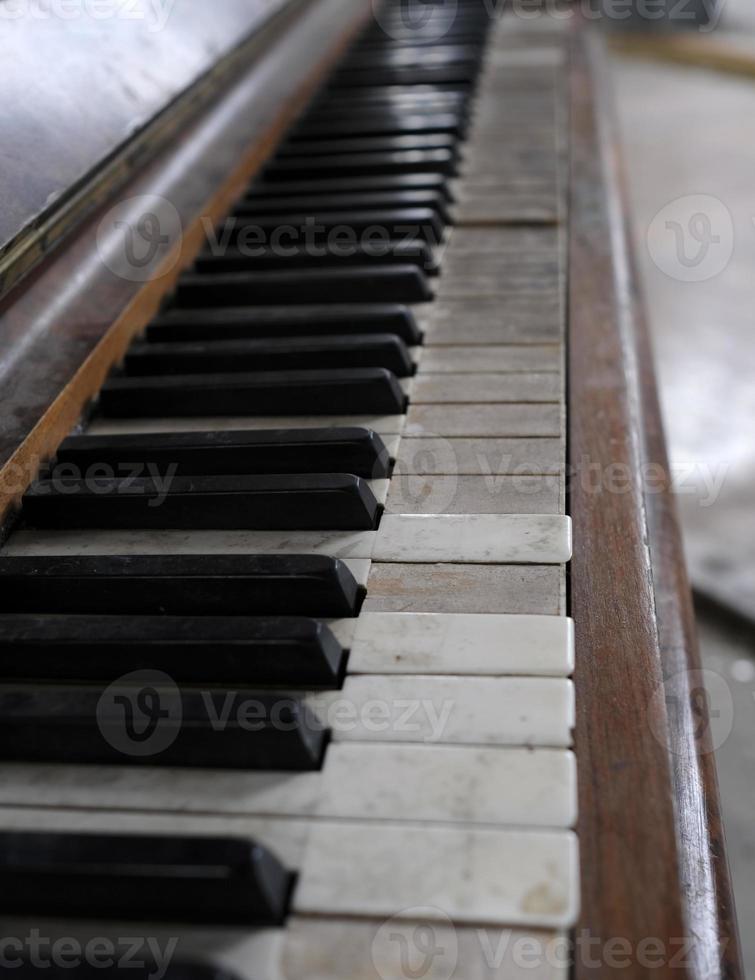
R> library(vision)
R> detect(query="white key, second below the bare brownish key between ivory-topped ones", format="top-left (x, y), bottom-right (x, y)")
top-left (304, 674), bottom-right (574, 748)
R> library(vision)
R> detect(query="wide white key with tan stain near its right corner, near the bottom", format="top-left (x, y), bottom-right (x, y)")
top-left (0, 807), bottom-right (577, 928)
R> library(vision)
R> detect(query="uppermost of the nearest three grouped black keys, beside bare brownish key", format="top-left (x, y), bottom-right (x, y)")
top-left (0, 555), bottom-right (363, 619)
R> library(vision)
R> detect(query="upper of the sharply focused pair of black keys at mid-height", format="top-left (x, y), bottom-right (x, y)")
top-left (52, 427), bottom-right (391, 480)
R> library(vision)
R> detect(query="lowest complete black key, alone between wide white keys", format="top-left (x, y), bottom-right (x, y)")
top-left (0, 831), bottom-right (293, 924)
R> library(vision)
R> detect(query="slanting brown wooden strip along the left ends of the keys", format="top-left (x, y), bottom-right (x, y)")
top-left (0, 0), bottom-right (370, 522)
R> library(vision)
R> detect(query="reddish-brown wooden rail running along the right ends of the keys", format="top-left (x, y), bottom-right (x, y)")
top-left (569, 26), bottom-right (743, 980)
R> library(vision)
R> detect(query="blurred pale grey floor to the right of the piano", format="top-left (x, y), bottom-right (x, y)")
top-left (613, 13), bottom-right (755, 964)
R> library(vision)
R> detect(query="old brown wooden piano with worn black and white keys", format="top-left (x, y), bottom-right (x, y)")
top-left (0, 0), bottom-right (743, 980)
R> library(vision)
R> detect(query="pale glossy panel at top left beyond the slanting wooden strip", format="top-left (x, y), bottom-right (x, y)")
top-left (0, 0), bottom-right (292, 292)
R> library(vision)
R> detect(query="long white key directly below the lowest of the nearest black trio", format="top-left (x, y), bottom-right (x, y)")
top-left (0, 742), bottom-right (576, 829)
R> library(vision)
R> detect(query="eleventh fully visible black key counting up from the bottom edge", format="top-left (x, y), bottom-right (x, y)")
top-left (194, 239), bottom-right (439, 276)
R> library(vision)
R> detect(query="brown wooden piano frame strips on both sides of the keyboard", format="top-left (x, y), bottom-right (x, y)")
top-left (0, 0), bottom-right (743, 980)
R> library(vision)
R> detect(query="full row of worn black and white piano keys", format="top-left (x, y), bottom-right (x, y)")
top-left (0, 0), bottom-right (579, 980)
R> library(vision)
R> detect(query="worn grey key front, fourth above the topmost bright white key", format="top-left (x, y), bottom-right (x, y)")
top-left (412, 372), bottom-right (563, 405)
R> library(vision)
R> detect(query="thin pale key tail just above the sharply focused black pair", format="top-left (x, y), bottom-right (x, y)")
top-left (86, 415), bottom-right (406, 436)
